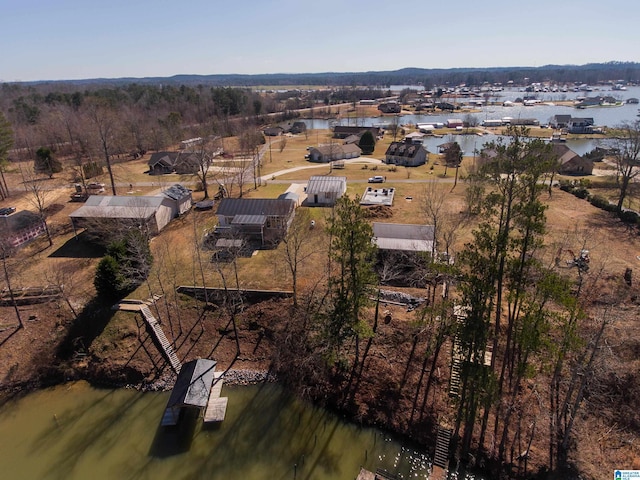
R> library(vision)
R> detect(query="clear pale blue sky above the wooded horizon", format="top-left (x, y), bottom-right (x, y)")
top-left (0, 0), bottom-right (640, 82)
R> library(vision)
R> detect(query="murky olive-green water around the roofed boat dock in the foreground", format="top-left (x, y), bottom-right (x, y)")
top-left (0, 382), bottom-right (430, 480)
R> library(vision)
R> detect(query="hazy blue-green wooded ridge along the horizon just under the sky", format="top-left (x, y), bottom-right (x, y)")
top-left (5, 62), bottom-right (640, 88)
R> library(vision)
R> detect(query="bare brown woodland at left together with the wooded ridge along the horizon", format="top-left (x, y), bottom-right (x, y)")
top-left (0, 62), bottom-right (640, 168)
